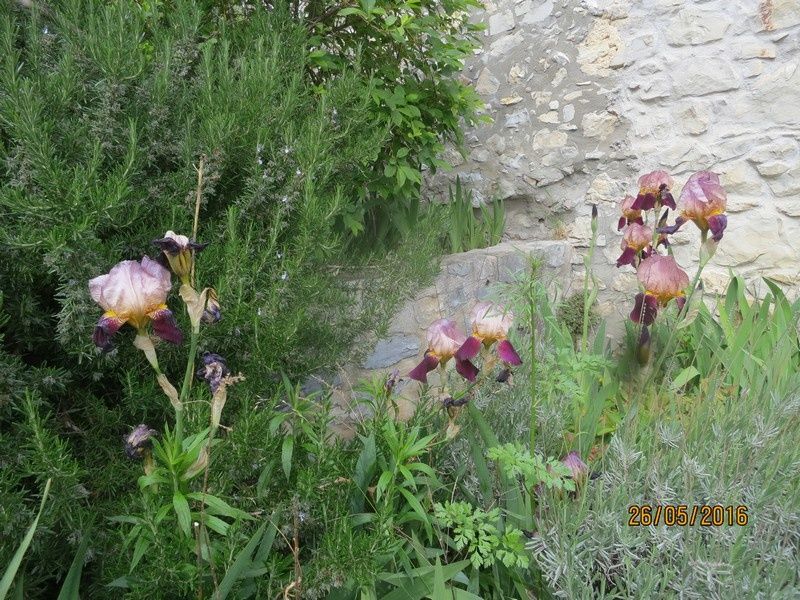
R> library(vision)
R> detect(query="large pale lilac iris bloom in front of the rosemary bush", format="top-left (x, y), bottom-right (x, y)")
top-left (89, 256), bottom-right (183, 351)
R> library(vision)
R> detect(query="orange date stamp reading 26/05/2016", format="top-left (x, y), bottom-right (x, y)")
top-left (628, 504), bottom-right (748, 527)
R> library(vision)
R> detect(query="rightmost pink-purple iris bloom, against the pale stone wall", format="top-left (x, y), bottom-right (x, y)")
top-left (659, 171), bottom-right (728, 242)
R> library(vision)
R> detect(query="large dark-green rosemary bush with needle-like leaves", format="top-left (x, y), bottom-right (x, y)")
top-left (0, 0), bottom-right (444, 597)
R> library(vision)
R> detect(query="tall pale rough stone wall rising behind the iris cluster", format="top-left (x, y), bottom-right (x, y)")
top-left (429, 0), bottom-right (800, 331)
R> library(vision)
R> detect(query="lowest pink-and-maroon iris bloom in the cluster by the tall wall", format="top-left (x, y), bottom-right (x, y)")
top-left (631, 254), bottom-right (689, 325)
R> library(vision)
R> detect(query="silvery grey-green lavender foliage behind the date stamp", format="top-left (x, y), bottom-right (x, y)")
top-left (528, 382), bottom-right (800, 599)
